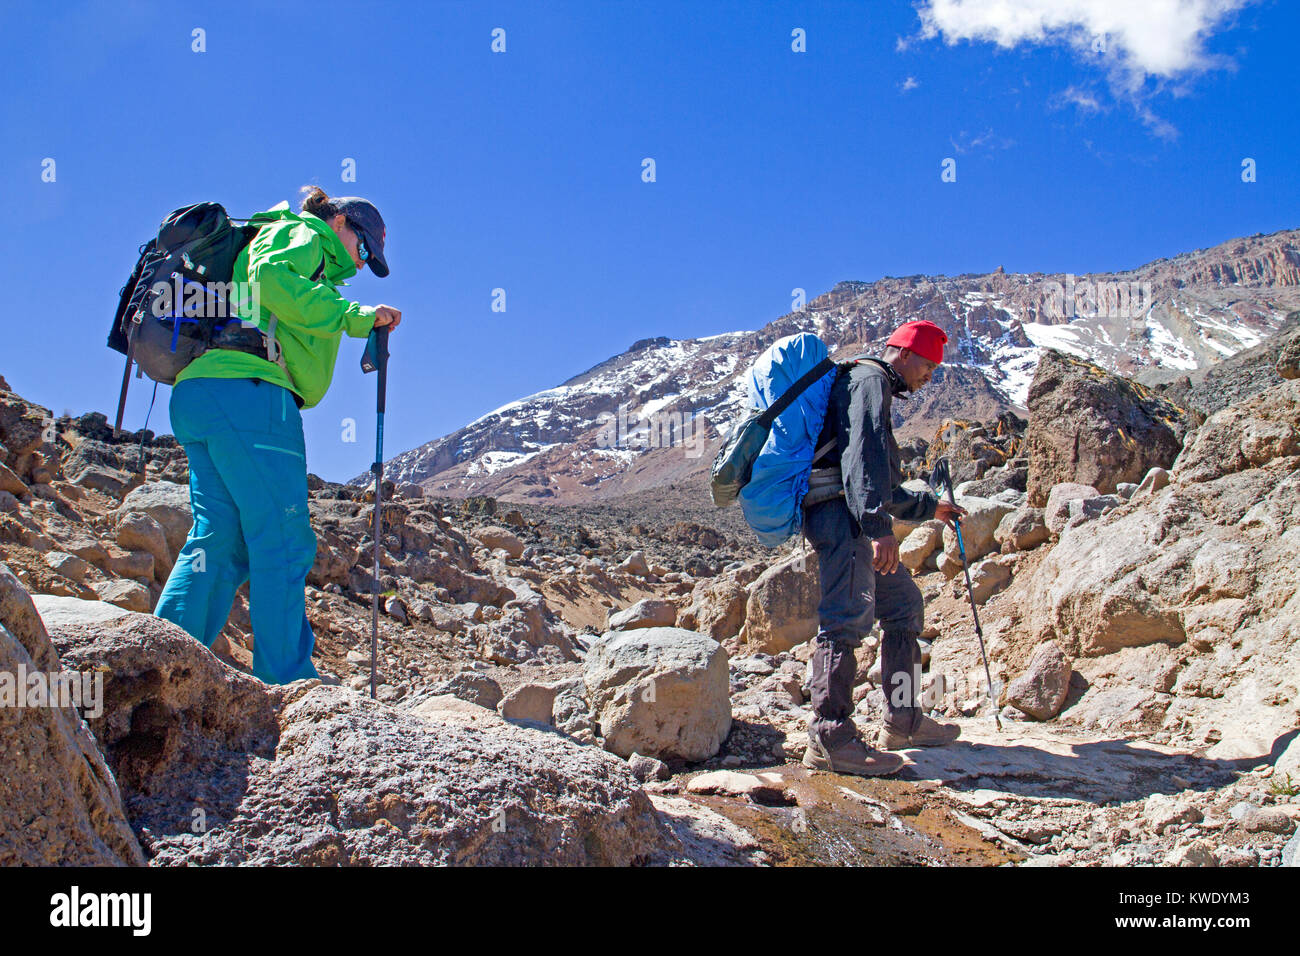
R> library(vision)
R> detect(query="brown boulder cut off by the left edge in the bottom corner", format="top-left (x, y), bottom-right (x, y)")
top-left (0, 564), bottom-right (144, 866)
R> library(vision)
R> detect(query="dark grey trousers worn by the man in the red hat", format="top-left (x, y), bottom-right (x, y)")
top-left (803, 498), bottom-right (926, 748)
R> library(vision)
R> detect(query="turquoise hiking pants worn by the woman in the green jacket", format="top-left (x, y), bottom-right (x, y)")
top-left (156, 378), bottom-right (319, 684)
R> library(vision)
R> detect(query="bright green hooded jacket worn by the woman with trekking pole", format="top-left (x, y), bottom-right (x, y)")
top-left (176, 203), bottom-right (374, 408)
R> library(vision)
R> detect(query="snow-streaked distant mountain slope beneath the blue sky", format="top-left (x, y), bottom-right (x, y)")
top-left (371, 230), bottom-right (1300, 502)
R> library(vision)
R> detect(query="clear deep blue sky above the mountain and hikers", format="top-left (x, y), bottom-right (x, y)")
top-left (0, 0), bottom-right (1300, 480)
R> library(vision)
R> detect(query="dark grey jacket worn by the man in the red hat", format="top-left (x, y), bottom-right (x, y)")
top-left (807, 358), bottom-right (939, 538)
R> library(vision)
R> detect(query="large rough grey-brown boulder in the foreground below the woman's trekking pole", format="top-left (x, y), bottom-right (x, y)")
top-left (153, 684), bottom-right (672, 866)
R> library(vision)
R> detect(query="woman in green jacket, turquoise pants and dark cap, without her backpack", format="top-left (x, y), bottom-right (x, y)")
top-left (156, 187), bottom-right (402, 684)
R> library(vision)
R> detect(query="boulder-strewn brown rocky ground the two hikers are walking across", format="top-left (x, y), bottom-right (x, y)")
top-left (0, 314), bottom-right (1300, 866)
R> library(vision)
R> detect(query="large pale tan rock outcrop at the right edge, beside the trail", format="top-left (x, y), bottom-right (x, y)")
top-left (1017, 380), bottom-right (1300, 758)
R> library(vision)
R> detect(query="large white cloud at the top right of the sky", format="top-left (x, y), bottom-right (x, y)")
top-left (900, 0), bottom-right (1255, 138)
